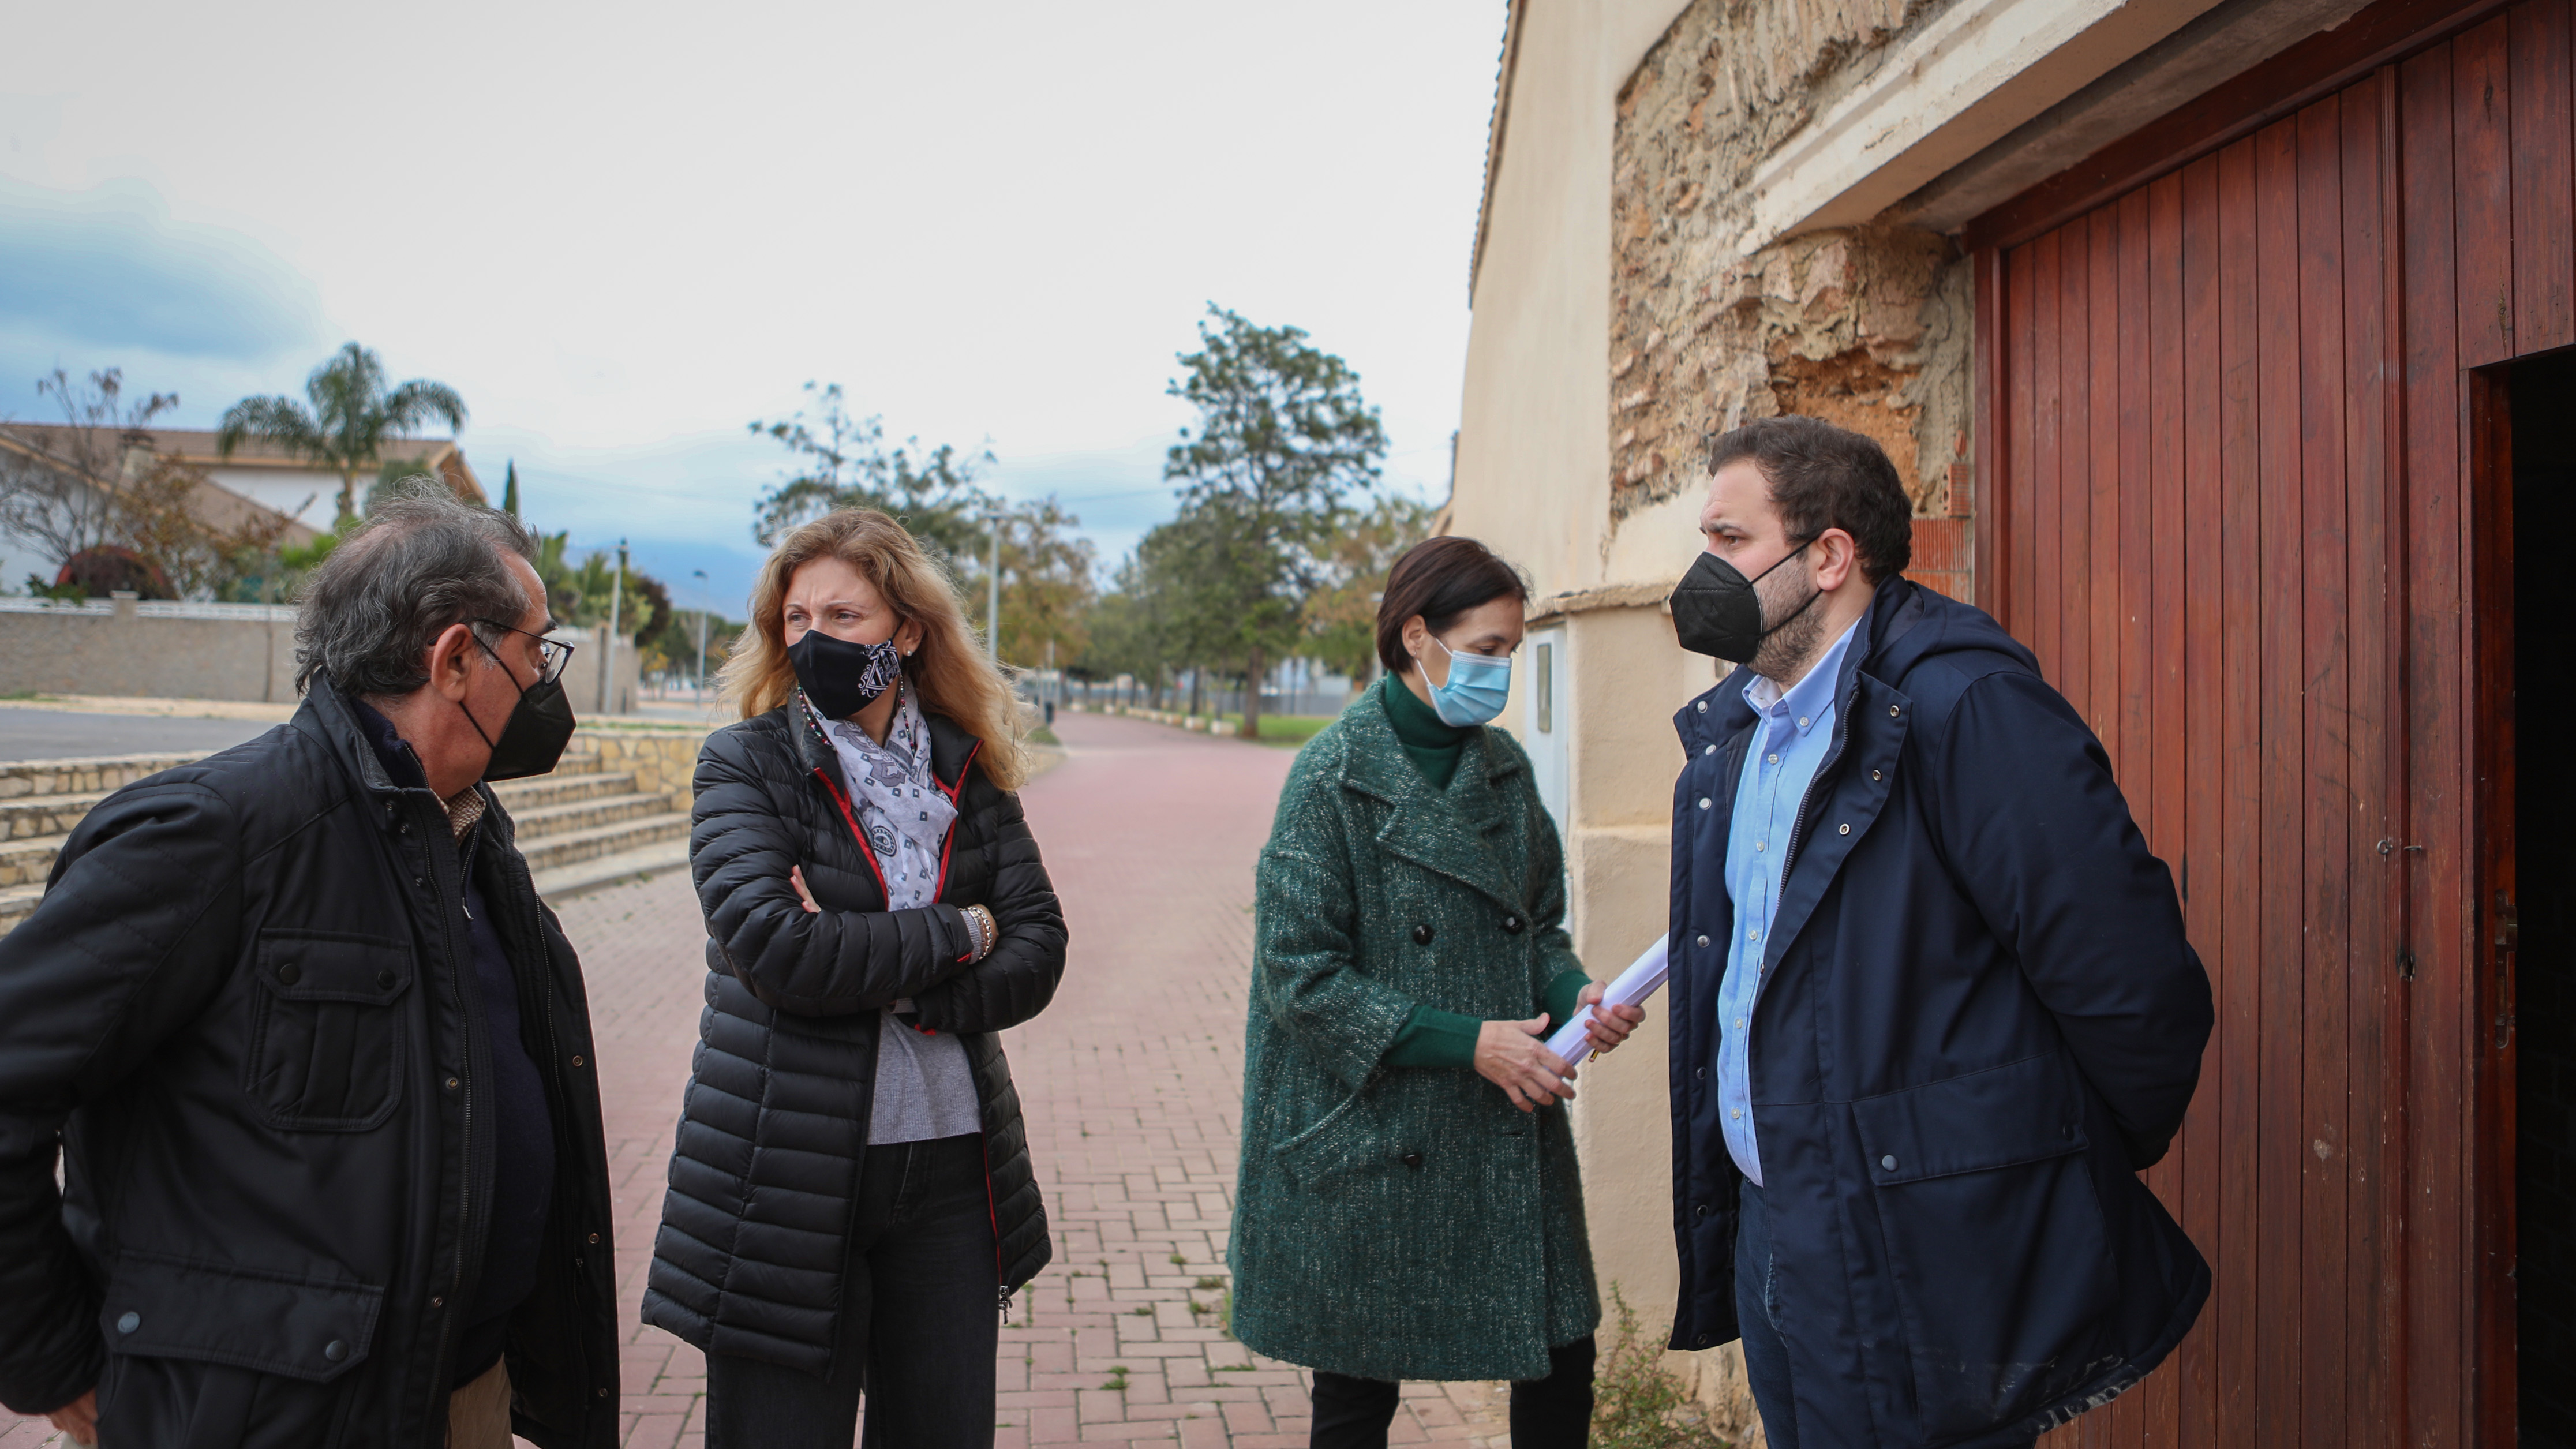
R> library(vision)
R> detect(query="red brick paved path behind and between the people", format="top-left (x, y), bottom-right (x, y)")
top-left (0, 714), bottom-right (1507, 1449)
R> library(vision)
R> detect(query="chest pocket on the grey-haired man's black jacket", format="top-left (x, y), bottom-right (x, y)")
top-left (242, 931), bottom-right (412, 1132)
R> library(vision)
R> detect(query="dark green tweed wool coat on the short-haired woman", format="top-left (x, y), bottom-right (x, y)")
top-left (1229, 691), bottom-right (1600, 1379)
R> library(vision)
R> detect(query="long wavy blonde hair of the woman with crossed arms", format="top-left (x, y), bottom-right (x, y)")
top-left (716, 508), bottom-right (1028, 789)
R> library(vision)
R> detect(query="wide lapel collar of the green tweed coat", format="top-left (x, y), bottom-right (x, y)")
top-left (1342, 691), bottom-right (1530, 910)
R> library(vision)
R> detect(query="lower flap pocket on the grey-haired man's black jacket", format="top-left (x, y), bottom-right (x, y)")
top-left (98, 1253), bottom-right (384, 1384)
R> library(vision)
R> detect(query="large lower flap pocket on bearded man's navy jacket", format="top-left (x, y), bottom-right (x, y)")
top-left (1852, 1054), bottom-right (2120, 1441)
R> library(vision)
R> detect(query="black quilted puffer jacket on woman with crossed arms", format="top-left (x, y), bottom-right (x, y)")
top-left (644, 699), bottom-right (1064, 1374)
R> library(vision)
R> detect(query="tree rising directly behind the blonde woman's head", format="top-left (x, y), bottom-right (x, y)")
top-left (750, 381), bottom-right (994, 564)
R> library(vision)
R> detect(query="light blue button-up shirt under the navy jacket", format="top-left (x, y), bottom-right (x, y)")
top-left (1718, 613), bottom-right (1860, 1186)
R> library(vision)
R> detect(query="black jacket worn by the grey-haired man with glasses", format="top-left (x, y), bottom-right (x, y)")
top-left (0, 681), bottom-right (618, 1449)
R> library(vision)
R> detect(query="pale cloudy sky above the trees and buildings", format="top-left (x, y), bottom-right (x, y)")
top-left (0, 0), bottom-right (1504, 616)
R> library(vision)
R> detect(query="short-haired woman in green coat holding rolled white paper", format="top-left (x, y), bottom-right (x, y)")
top-left (1231, 539), bottom-right (1643, 1449)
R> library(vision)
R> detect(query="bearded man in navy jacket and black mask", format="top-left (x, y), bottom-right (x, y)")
top-left (1672, 418), bottom-right (2210, 1449)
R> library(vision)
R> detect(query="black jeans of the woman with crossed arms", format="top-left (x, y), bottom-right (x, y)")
top-left (706, 1135), bottom-right (1002, 1449)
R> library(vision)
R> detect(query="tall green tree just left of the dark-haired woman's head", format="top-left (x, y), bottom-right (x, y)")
top-left (1162, 302), bottom-right (1386, 735)
